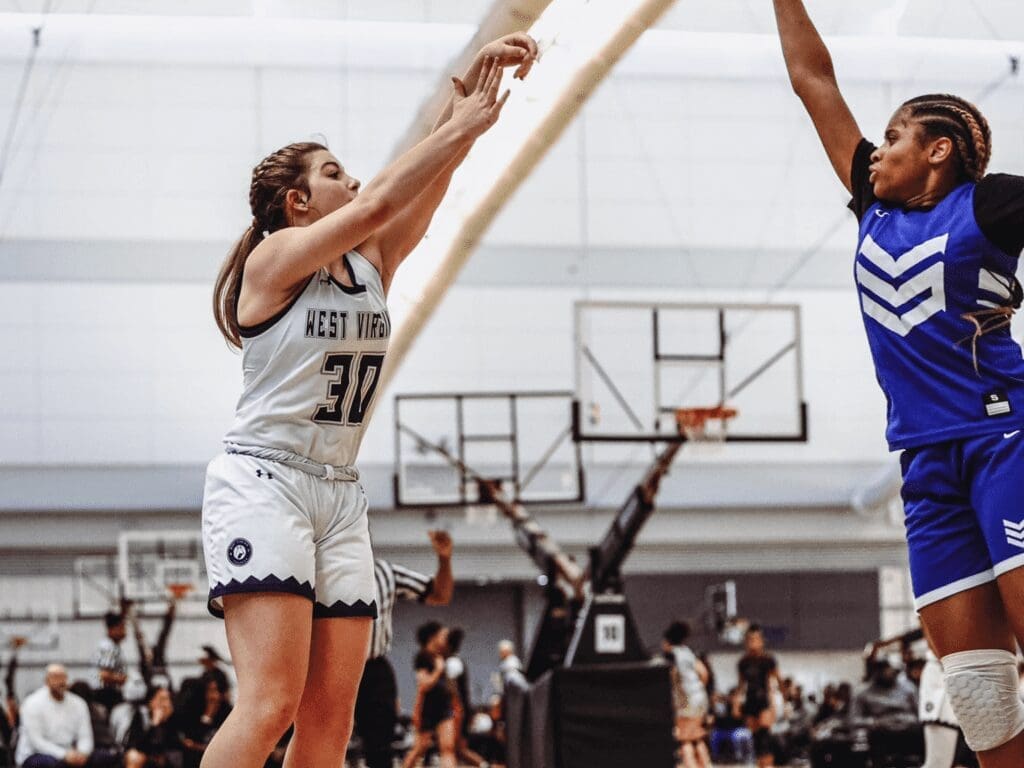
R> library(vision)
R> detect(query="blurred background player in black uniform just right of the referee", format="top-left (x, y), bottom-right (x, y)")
top-left (402, 622), bottom-right (456, 768)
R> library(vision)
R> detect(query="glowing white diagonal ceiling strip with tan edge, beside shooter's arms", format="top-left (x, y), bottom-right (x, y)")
top-left (384, 0), bottom-right (673, 382)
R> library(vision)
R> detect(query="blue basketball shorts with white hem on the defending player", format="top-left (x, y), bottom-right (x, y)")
top-left (900, 427), bottom-right (1024, 610)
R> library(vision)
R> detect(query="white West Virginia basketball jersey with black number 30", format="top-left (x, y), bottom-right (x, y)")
top-left (224, 251), bottom-right (391, 466)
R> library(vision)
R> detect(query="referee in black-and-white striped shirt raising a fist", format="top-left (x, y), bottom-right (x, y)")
top-left (355, 530), bottom-right (455, 768)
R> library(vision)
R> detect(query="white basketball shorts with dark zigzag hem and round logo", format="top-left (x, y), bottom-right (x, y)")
top-left (203, 454), bottom-right (377, 618)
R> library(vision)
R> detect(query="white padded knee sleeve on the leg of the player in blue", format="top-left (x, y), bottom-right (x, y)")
top-left (942, 650), bottom-right (1024, 752)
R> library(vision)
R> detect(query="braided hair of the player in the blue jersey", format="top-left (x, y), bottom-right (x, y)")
top-left (901, 93), bottom-right (992, 181)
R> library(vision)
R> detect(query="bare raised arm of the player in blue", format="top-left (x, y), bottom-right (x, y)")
top-left (774, 0), bottom-right (862, 191)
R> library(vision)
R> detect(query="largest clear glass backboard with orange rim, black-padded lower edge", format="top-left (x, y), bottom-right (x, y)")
top-left (573, 301), bottom-right (807, 442)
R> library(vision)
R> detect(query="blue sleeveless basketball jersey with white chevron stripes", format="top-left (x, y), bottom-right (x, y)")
top-left (853, 142), bottom-right (1024, 451)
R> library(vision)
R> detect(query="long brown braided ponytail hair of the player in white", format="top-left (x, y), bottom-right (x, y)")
top-left (213, 141), bottom-right (327, 348)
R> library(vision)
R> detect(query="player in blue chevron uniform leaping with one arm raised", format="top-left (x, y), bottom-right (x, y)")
top-left (774, 0), bottom-right (1024, 768)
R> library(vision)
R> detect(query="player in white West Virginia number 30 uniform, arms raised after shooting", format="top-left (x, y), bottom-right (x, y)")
top-left (195, 34), bottom-right (537, 768)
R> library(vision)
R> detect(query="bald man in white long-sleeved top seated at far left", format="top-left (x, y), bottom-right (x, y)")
top-left (15, 664), bottom-right (92, 768)
